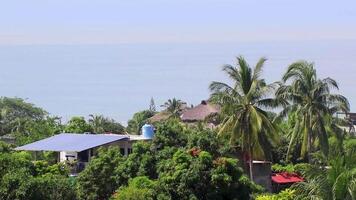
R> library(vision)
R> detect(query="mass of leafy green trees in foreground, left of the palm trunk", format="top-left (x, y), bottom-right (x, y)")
top-left (0, 120), bottom-right (261, 199)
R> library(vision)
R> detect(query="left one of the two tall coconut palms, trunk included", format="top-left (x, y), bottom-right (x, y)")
top-left (210, 57), bottom-right (278, 180)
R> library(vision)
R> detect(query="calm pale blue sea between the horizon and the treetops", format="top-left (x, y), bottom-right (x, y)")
top-left (0, 41), bottom-right (356, 123)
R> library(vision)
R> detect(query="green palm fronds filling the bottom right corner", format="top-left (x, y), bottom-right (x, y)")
top-left (292, 151), bottom-right (356, 200)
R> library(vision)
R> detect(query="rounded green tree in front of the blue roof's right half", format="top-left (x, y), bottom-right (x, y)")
top-left (77, 147), bottom-right (123, 200)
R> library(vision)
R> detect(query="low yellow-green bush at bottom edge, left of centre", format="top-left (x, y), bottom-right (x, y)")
top-left (113, 176), bottom-right (156, 200)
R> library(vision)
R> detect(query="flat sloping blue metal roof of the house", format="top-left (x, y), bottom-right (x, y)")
top-left (15, 133), bottom-right (129, 152)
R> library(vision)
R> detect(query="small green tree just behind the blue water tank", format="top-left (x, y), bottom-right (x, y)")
top-left (127, 110), bottom-right (155, 134)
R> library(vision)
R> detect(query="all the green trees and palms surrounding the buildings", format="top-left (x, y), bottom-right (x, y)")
top-left (0, 57), bottom-right (356, 200)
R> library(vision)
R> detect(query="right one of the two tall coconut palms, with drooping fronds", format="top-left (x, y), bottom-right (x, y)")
top-left (276, 61), bottom-right (349, 162)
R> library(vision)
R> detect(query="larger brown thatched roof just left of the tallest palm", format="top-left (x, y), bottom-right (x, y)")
top-left (181, 101), bottom-right (220, 122)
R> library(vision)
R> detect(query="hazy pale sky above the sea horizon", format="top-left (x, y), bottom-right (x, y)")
top-left (0, 0), bottom-right (356, 44)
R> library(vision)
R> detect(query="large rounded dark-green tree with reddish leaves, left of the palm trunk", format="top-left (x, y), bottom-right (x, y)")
top-left (157, 150), bottom-right (254, 199)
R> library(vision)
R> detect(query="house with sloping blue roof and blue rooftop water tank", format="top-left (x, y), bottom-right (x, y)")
top-left (15, 125), bottom-right (153, 172)
